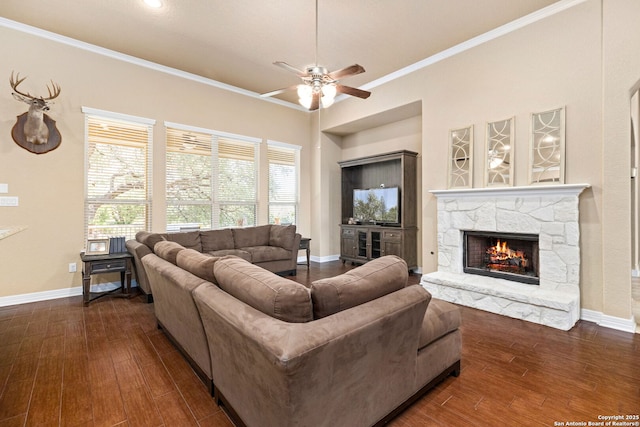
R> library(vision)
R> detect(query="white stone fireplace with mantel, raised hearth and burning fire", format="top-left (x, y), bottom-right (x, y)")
top-left (421, 184), bottom-right (589, 330)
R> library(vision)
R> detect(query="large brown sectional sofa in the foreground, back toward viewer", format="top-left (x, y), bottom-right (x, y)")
top-left (142, 242), bottom-right (461, 426)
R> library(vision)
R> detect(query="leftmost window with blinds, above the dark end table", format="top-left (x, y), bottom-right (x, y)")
top-left (82, 108), bottom-right (155, 239)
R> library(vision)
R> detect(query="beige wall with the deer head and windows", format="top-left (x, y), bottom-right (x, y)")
top-left (0, 27), bottom-right (311, 297)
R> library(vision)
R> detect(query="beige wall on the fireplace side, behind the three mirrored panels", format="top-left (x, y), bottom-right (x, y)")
top-left (325, 0), bottom-right (640, 319)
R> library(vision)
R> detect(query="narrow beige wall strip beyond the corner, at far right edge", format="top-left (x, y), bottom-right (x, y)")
top-left (596, 0), bottom-right (640, 318)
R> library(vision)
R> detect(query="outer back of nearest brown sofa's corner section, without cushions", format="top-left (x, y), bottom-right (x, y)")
top-left (193, 285), bottom-right (430, 426)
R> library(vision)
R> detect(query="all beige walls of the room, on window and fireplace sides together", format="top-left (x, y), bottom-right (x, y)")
top-left (0, 0), bottom-right (640, 424)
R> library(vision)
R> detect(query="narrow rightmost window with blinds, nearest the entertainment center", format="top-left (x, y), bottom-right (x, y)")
top-left (267, 141), bottom-right (301, 224)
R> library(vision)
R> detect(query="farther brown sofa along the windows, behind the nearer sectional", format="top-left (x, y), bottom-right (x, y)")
top-left (126, 224), bottom-right (301, 302)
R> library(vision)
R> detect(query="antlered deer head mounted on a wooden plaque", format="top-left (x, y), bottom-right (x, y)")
top-left (9, 72), bottom-right (62, 154)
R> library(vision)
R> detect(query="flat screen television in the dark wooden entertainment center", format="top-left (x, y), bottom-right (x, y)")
top-left (353, 187), bottom-right (400, 225)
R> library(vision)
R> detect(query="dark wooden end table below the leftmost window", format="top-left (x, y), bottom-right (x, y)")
top-left (80, 252), bottom-right (133, 306)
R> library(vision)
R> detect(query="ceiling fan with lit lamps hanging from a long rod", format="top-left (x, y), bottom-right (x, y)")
top-left (260, 0), bottom-right (371, 111)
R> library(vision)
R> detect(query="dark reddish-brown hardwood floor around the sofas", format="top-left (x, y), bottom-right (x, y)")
top-left (0, 262), bottom-right (640, 427)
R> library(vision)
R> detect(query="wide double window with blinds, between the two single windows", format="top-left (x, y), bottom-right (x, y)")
top-left (166, 123), bottom-right (260, 230)
